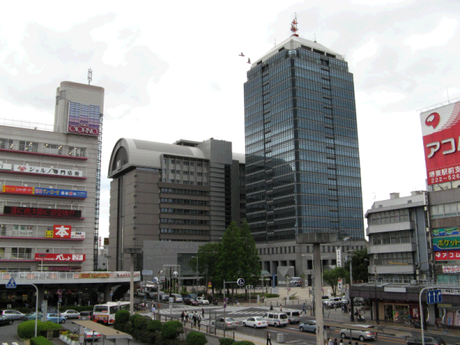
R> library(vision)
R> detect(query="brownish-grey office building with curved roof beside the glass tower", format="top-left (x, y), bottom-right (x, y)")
top-left (108, 139), bottom-right (245, 270)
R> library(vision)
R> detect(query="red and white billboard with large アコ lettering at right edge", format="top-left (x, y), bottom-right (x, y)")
top-left (420, 102), bottom-right (460, 185)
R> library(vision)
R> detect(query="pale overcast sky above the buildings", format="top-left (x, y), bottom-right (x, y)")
top-left (0, 0), bottom-right (460, 236)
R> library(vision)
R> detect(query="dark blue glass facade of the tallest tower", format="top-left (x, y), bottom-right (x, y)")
top-left (244, 37), bottom-right (364, 242)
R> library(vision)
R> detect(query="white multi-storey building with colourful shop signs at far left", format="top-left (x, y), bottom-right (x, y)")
top-left (0, 82), bottom-right (104, 272)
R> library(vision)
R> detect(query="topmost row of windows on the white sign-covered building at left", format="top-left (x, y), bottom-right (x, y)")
top-left (0, 138), bottom-right (86, 157)
